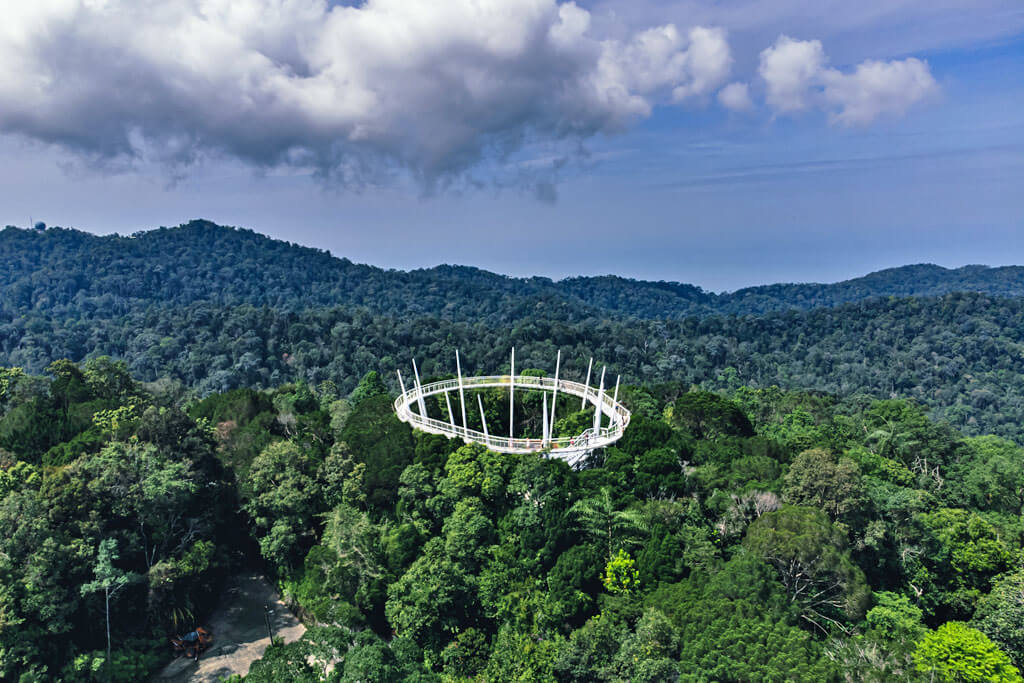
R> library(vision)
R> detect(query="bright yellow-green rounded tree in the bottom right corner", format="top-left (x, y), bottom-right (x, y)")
top-left (913, 622), bottom-right (1024, 683)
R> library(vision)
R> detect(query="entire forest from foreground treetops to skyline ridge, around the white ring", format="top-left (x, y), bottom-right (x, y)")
top-left (0, 221), bottom-right (1024, 683)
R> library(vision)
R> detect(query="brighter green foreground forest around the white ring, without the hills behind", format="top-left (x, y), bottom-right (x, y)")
top-left (0, 360), bottom-right (1024, 683)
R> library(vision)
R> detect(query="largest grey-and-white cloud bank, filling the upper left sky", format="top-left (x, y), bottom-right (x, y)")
top-left (0, 0), bottom-right (737, 184)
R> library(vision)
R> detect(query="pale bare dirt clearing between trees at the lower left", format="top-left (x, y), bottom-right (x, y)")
top-left (153, 573), bottom-right (306, 683)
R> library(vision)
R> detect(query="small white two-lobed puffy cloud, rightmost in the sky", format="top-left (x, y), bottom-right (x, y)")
top-left (759, 36), bottom-right (938, 125)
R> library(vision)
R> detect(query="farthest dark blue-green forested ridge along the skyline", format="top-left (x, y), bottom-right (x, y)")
top-left (0, 220), bottom-right (1024, 324)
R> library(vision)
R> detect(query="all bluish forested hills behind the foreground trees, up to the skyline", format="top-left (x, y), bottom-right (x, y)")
top-left (0, 221), bottom-right (1024, 441)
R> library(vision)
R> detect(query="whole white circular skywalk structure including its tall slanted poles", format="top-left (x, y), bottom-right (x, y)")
top-left (394, 348), bottom-right (630, 465)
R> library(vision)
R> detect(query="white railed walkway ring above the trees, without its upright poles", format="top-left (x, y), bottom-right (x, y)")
top-left (394, 375), bottom-right (630, 462)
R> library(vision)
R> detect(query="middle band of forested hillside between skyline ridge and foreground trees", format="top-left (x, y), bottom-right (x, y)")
top-left (0, 294), bottom-right (1024, 440)
